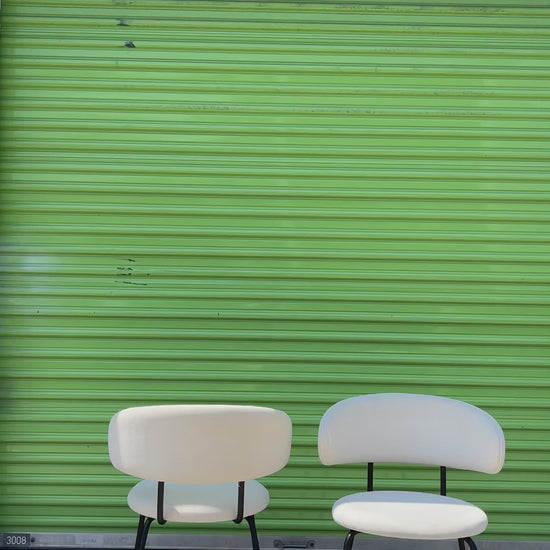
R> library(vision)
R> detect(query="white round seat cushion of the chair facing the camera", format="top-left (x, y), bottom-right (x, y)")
top-left (332, 491), bottom-right (487, 540)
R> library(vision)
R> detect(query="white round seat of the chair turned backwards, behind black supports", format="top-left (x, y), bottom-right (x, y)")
top-left (128, 480), bottom-right (269, 523)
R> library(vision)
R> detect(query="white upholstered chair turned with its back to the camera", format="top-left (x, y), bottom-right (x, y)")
top-left (109, 405), bottom-right (292, 550)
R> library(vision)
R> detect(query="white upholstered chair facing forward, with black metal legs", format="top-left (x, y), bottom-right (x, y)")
top-left (319, 393), bottom-right (505, 550)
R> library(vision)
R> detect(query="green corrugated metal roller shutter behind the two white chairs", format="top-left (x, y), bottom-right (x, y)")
top-left (1, 0), bottom-right (550, 540)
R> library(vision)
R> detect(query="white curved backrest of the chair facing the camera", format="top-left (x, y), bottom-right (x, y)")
top-left (319, 393), bottom-right (505, 474)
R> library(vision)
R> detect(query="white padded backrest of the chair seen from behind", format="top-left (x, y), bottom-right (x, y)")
top-left (109, 405), bottom-right (292, 484)
